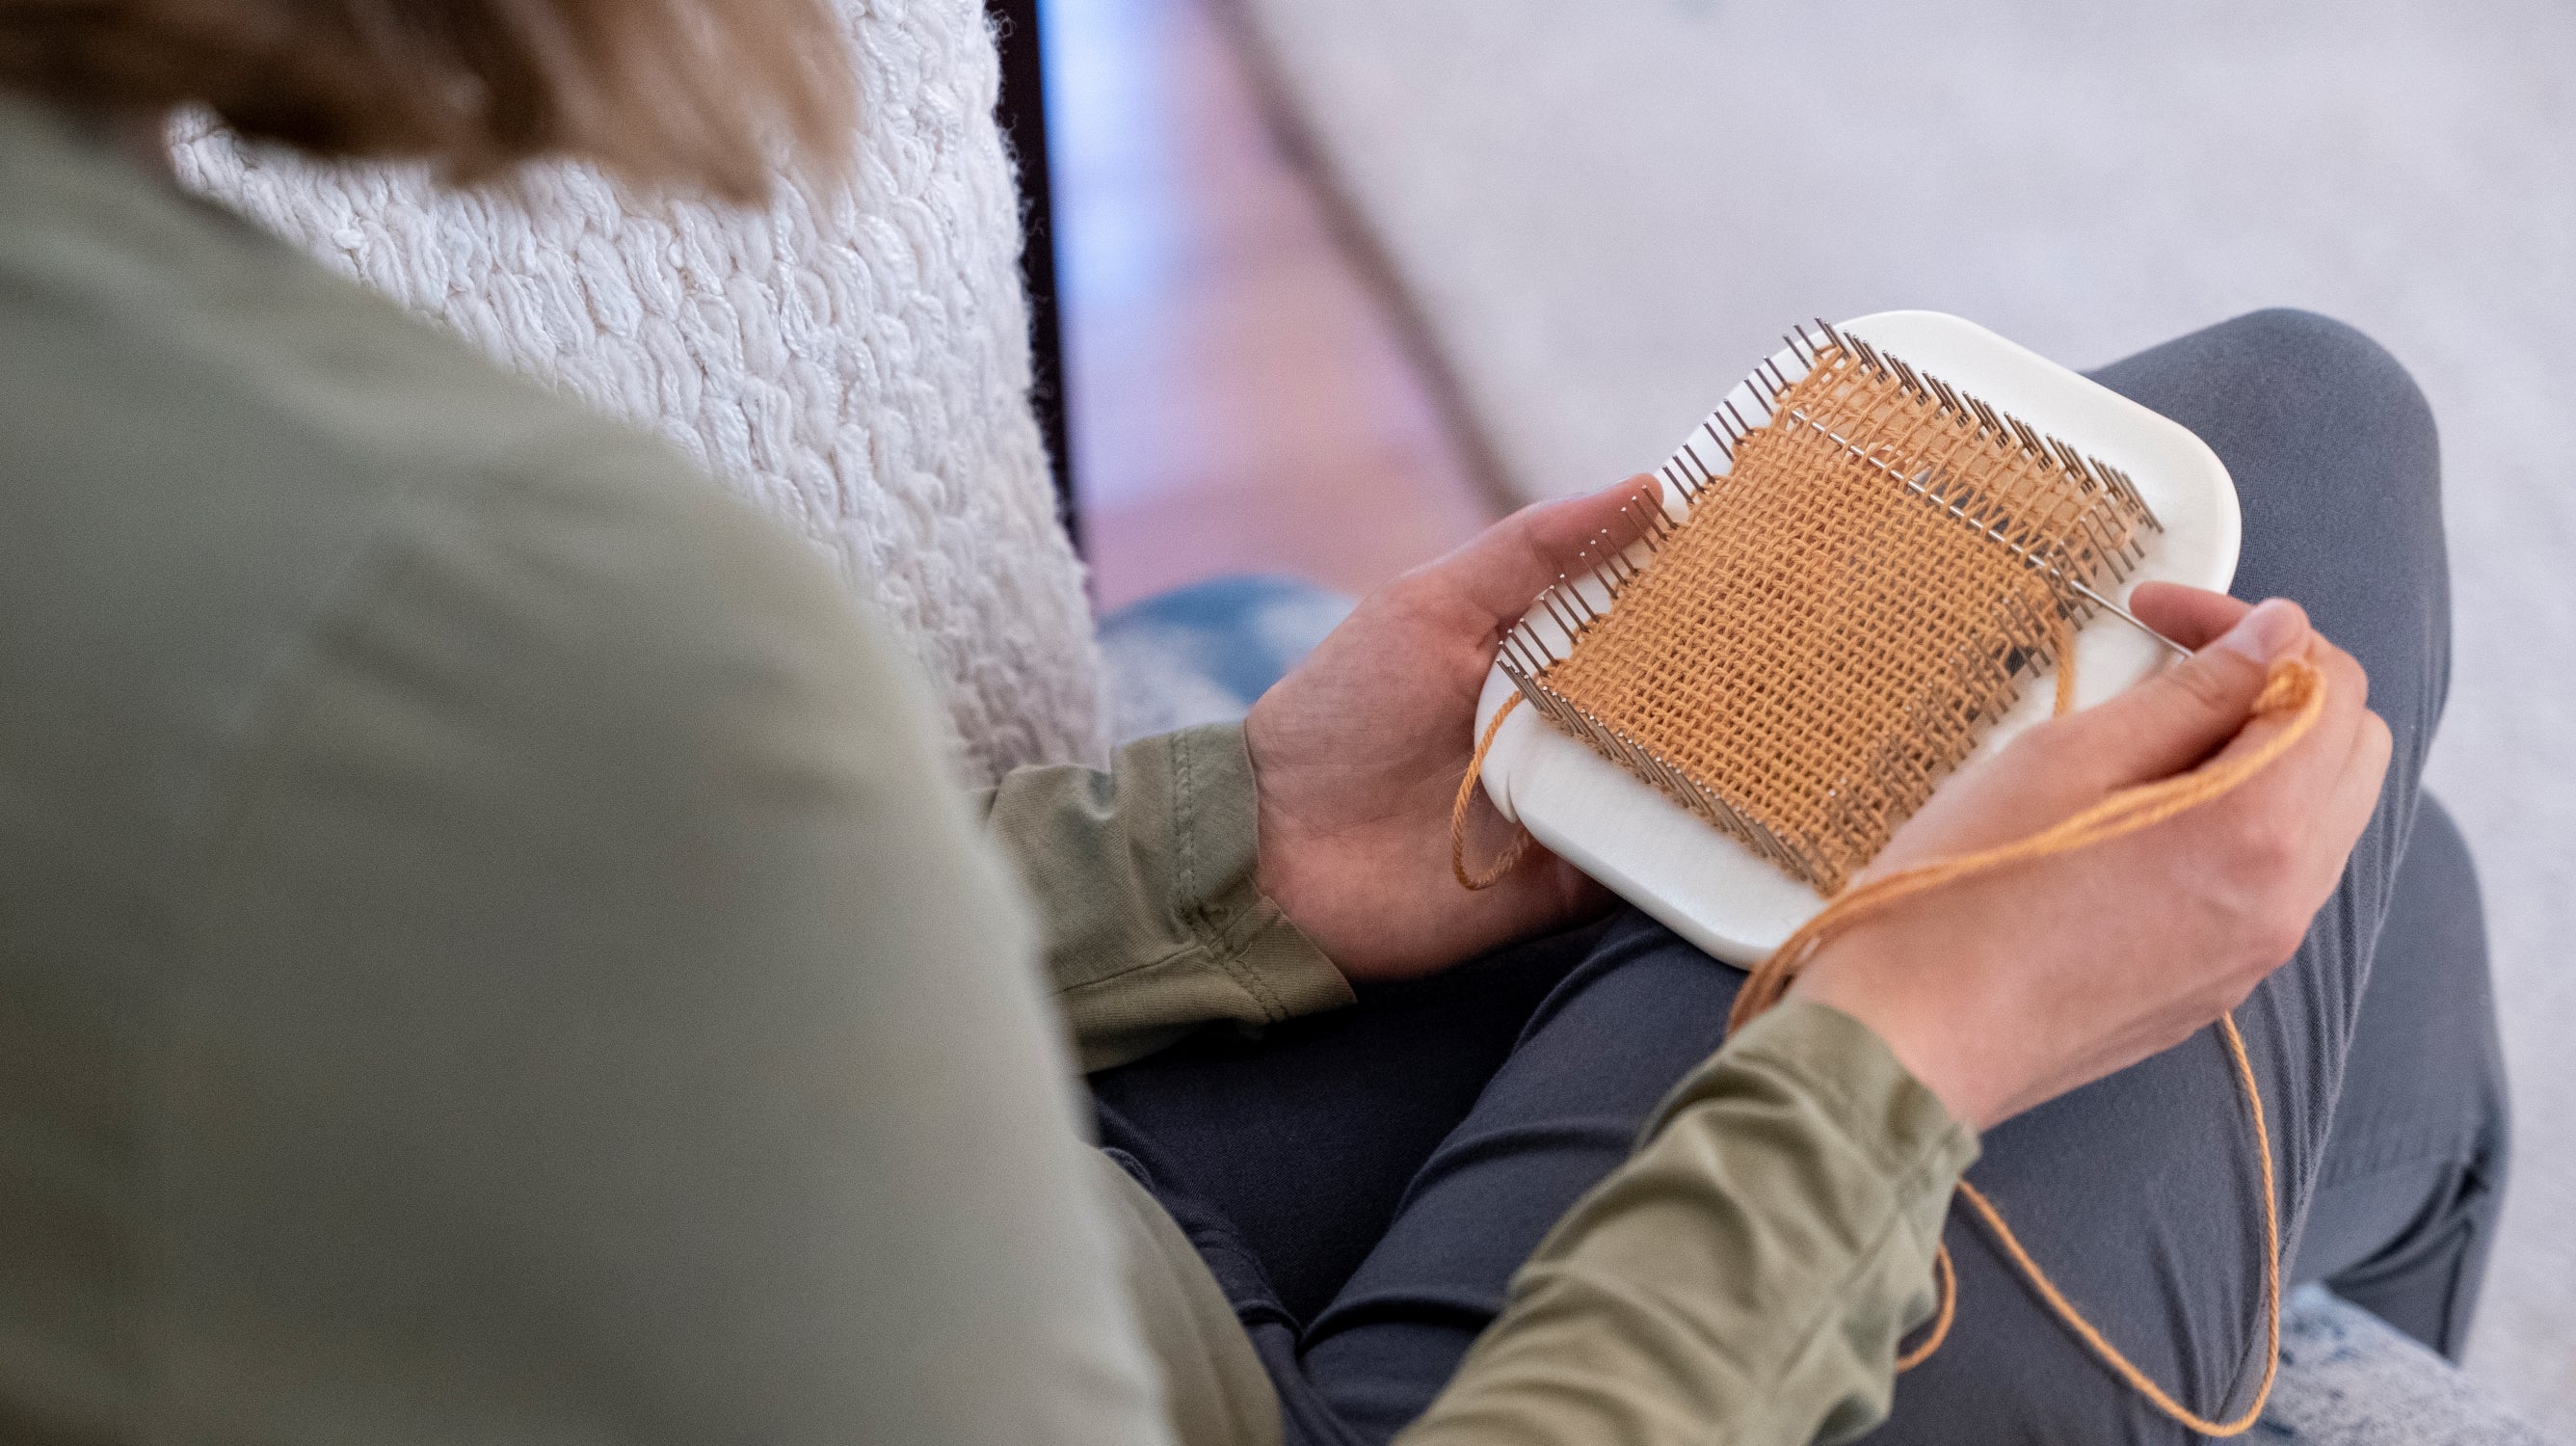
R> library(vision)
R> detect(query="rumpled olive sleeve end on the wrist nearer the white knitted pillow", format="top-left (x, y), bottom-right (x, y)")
top-left (979, 724), bottom-right (1350, 1072)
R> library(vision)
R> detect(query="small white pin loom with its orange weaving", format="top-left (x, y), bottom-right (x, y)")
top-left (1478, 312), bottom-right (2236, 959)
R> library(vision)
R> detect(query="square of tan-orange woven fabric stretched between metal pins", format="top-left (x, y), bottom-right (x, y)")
top-left (1538, 348), bottom-right (2148, 895)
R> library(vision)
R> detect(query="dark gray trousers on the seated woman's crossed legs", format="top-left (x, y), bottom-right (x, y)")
top-left (1095, 312), bottom-right (2504, 1446)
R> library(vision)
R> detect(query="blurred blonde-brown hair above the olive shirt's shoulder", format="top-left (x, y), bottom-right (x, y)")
top-left (0, 0), bottom-right (855, 201)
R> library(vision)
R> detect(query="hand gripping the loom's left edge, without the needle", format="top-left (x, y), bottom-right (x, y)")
top-left (1244, 477), bottom-right (1659, 982)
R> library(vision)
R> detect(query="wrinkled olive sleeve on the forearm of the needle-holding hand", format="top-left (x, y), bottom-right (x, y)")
top-left (1398, 1000), bottom-right (1976, 1446)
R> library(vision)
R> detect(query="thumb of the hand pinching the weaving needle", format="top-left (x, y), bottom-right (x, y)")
top-left (2063, 598), bottom-right (2311, 784)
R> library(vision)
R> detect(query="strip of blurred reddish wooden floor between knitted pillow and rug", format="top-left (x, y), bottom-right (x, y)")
top-left (1046, 0), bottom-right (1492, 611)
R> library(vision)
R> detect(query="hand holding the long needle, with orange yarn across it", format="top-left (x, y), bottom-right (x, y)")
top-left (1793, 582), bottom-right (2388, 1129)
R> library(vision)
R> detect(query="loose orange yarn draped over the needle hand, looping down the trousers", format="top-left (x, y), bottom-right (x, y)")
top-left (1726, 652), bottom-right (2326, 1435)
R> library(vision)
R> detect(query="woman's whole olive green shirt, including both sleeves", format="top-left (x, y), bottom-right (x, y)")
top-left (0, 100), bottom-right (1976, 1443)
